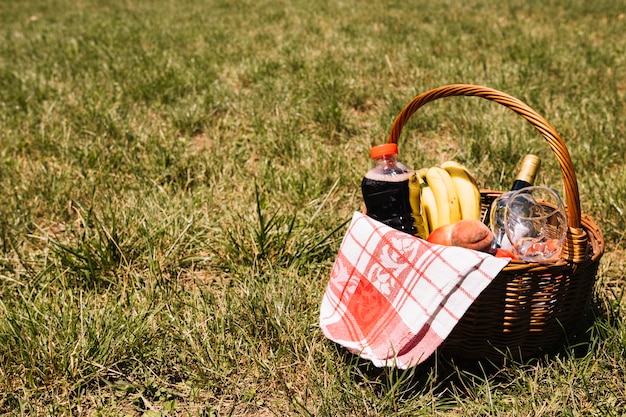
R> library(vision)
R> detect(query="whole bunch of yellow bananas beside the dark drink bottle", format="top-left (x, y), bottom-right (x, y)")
top-left (409, 161), bottom-right (480, 239)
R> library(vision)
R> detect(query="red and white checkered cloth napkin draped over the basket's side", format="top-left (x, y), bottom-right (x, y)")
top-left (320, 212), bottom-right (509, 369)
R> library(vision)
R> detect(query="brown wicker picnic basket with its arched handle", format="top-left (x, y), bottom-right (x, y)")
top-left (388, 84), bottom-right (604, 361)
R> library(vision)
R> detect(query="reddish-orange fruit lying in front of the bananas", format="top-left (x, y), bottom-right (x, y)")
top-left (427, 219), bottom-right (493, 253)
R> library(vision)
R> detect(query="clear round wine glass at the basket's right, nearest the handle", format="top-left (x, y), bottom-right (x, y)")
top-left (504, 186), bottom-right (567, 262)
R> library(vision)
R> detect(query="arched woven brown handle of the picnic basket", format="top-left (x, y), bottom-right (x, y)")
top-left (388, 84), bottom-right (582, 229)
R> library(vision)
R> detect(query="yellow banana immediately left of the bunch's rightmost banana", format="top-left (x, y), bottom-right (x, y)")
top-left (426, 167), bottom-right (461, 231)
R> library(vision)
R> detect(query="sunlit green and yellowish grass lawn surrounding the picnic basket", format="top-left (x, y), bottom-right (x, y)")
top-left (0, 0), bottom-right (626, 416)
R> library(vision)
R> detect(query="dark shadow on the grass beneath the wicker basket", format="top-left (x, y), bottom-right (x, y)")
top-left (336, 290), bottom-right (619, 401)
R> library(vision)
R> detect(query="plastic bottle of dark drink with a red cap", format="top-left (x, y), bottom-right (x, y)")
top-left (361, 143), bottom-right (416, 235)
